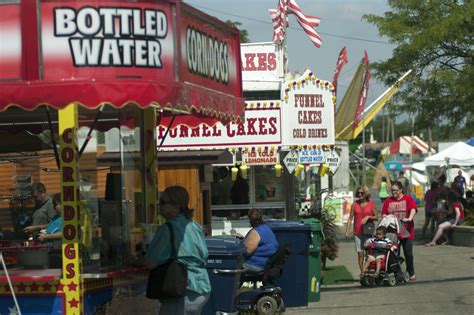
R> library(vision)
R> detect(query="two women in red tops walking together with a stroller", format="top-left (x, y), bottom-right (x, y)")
top-left (346, 181), bottom-right (417, 281)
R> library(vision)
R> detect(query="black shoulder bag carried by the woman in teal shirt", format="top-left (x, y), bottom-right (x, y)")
top-left (146, 222), bottom-right (188, 300)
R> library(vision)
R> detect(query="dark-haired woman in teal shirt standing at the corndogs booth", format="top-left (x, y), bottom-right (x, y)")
top-left (144, 186), bottom-right (211, 315)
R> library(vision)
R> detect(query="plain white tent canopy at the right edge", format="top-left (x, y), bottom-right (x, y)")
top-left (424, 141), bottom-right (474, 167)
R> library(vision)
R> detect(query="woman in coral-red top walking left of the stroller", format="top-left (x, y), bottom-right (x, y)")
top-left (346, 185), bottom-right (378, 274)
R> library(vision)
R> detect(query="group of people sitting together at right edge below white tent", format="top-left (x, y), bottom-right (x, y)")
top-left (423, 171), bottom-right (472, 246)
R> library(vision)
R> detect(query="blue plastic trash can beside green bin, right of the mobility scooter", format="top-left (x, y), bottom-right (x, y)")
top-left (268, 221), bottom-right (311, 307)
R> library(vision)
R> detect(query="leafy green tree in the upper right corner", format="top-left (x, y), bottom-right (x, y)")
top-left (364, 0), bottom-right (474, 138)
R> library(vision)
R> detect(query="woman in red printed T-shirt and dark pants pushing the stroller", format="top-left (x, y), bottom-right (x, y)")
top-left (382, 182), bottom-right (418, 281)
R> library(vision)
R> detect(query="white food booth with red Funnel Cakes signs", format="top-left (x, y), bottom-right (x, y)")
top-left (157, 64), bottom-right (340, 235)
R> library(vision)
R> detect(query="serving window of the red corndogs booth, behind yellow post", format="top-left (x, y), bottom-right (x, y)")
top-left (0, 106), bottom-right (146, 272)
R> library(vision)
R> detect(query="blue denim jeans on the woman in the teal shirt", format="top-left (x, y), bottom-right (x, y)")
top-left (158, 290), bottom-right (210, 315)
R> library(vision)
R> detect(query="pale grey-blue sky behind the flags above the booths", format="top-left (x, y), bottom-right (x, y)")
top-left (184, 0), bottom-right (394, 106)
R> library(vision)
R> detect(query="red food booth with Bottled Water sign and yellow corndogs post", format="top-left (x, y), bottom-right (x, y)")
top-left (0, 0), bottom-right (244, 314)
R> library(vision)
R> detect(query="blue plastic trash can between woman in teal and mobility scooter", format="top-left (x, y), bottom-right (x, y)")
top-left (202, 237), bottom-right (245, 315)
